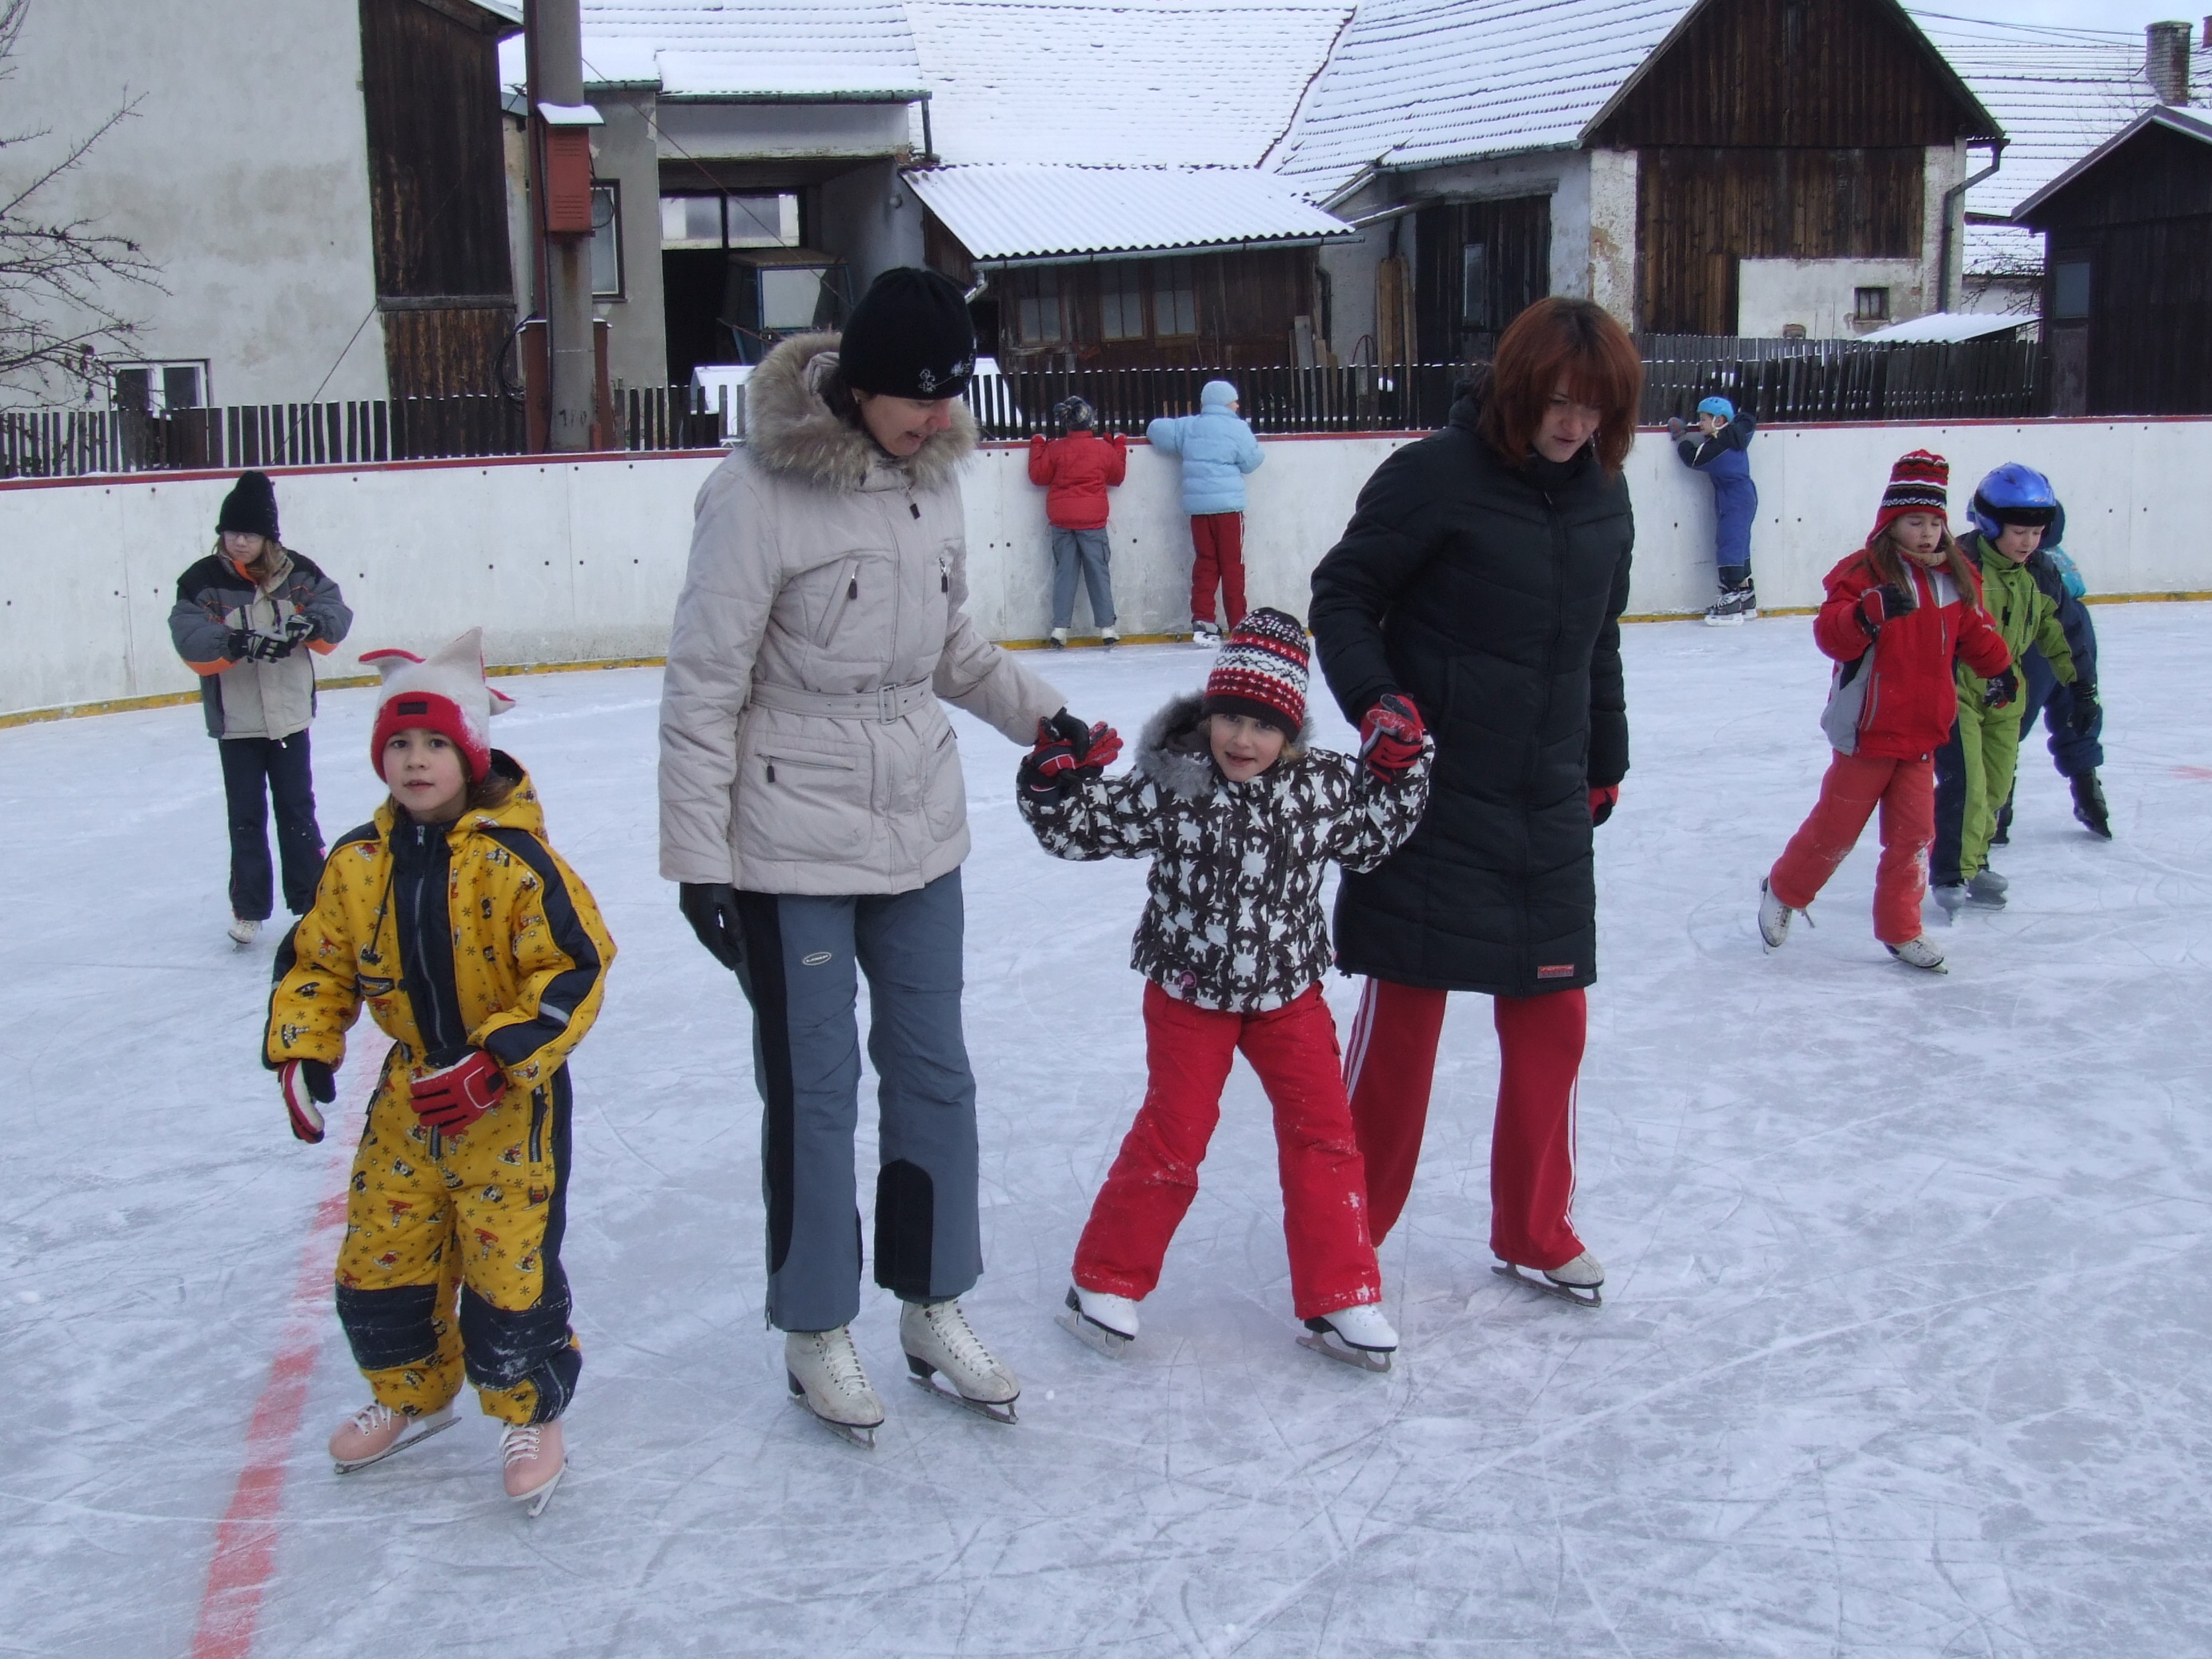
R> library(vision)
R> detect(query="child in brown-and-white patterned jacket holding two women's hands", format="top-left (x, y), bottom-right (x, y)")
top-left (1016, 611), bottom-right (1431, 1372)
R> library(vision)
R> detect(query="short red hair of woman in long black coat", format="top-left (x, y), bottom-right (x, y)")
top-left (1480, 296), bottom-right (1644, 473)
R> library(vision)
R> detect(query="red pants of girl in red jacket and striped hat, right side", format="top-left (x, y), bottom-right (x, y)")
top-left (1767, 755), bottom-right (1936, 944)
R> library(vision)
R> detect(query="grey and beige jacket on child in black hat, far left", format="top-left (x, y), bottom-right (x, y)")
top-left (168, 548), bottom-right (354, 736)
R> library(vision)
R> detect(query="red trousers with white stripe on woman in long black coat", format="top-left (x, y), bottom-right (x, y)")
top-left (1347, 980), bottom-right (1590, 1270)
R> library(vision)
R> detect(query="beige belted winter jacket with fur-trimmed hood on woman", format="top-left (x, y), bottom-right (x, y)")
top-left (661, 334), bottom-right (1066, 894)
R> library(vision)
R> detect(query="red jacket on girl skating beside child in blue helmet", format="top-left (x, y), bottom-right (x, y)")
top-left (1812, 548), bottom-right (2013, 761)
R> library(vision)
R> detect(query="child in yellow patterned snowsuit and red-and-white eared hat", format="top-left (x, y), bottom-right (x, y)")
top-left (263, 631), bottom-right (615, 1515)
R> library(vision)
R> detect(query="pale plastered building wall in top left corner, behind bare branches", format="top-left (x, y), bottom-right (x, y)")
top-left (5, 0), bottom-right (385, 403)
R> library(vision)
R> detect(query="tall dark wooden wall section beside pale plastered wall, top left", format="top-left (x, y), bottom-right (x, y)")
top-left (361, 0), bottom-right (515, 399)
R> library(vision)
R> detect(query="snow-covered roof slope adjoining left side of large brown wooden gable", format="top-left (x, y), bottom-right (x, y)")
top-left (1270, 0), bottom-right (1694, 199)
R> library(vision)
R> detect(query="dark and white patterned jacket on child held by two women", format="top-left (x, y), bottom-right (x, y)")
top-left (1016, 697), bottom-right (1433, 1013)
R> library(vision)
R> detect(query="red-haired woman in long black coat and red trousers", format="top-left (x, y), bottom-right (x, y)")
top-left (1312, 299), bottom-right (1644, 1303)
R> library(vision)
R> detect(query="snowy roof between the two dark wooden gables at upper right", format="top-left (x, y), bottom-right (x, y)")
top-left (1911, 11), bottom-right (2212, 274)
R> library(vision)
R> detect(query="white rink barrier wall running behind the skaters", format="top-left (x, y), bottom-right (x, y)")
top-left (0, 418), bottom-right (2212, 719)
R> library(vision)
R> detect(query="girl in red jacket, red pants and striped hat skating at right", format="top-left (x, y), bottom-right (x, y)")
top-left (1758, 449), bottom-right (2013, 973)
